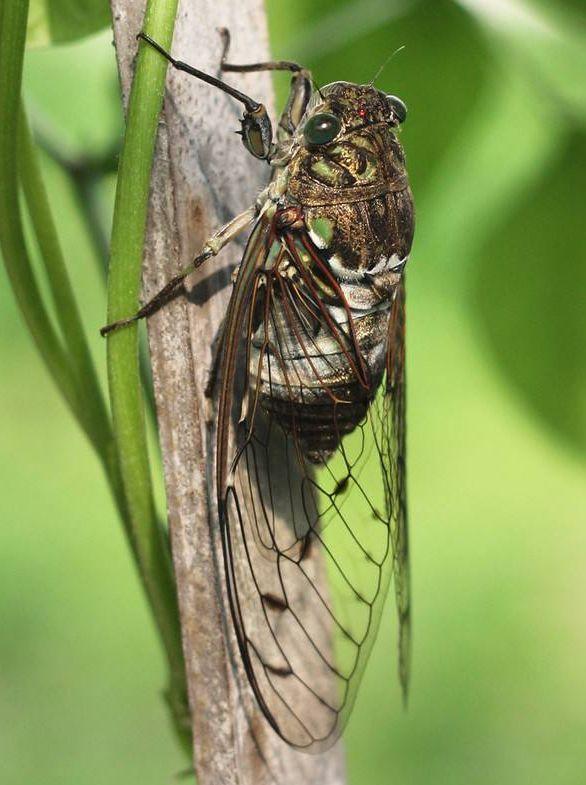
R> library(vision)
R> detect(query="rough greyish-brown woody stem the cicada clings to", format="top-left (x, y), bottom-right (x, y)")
top-left (112, 0), bottom-right (345, 785)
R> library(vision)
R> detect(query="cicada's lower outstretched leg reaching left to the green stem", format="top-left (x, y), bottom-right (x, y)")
top-left (100, 205), bottom-right (258, 335)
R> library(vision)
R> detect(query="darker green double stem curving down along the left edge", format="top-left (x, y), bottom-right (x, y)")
top-left (0, 2), bottom-right (126, 544)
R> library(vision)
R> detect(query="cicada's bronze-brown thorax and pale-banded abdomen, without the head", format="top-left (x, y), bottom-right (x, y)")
top-left (251, 113), bottom-right (413, 463)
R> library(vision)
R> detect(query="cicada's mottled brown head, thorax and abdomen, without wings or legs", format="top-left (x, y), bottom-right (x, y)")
top-left (253, 82), bottom-right (413, 454)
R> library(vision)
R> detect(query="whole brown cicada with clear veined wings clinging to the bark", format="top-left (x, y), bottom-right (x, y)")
top-left (102, 31), bottom-right (414, 751)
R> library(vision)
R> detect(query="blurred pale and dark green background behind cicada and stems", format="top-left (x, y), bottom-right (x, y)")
top-left (0, 0), bottom-right (586, 785)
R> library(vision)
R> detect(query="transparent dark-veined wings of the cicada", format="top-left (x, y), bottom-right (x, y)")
top-left (217, 210), bottom-right (409, 752)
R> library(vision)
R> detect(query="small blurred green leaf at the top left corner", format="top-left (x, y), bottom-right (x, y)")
top-left (27, 0), bottom-right (110, 46)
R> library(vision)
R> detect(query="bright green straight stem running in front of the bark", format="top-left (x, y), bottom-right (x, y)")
top-left (108, 0), bottom-right (191, 748)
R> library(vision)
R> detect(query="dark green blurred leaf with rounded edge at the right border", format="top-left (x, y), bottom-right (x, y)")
top-left (474, 135), bottom-right (586, 452)
